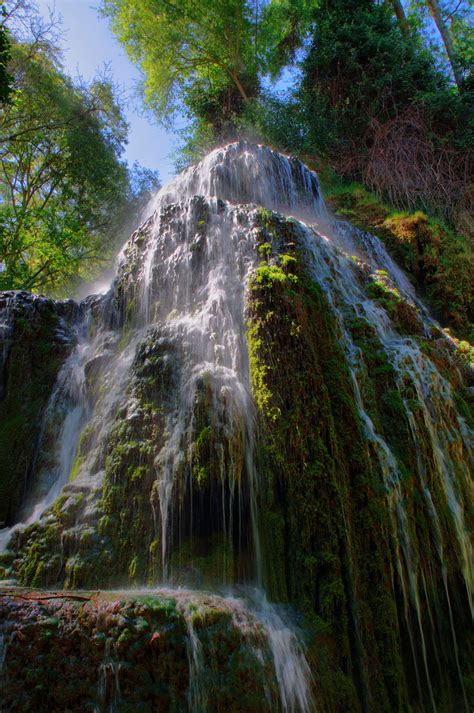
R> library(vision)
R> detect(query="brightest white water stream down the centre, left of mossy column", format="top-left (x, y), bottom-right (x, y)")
top-left (135, 197), bottom-right (262, 579)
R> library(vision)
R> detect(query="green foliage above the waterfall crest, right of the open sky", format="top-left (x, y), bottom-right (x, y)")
top-left (102, 0), bottom-right (474, 233)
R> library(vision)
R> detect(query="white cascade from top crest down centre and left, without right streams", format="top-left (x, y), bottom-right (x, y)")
top-left (0, 142), bottom-right (319, 712)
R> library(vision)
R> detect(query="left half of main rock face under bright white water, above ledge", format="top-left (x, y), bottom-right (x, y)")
top-left (0, 197), bottom-right (262, 587)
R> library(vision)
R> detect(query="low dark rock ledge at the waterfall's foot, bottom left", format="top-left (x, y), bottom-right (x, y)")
top-left (0, 593), bottom-right (278, 713)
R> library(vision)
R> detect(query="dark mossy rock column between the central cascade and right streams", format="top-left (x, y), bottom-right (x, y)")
top-left (247, 209), bottom-right (470, 712)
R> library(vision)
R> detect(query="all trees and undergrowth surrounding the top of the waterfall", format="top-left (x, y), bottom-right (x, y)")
top-left (0, 0), bottom-right (474, 341)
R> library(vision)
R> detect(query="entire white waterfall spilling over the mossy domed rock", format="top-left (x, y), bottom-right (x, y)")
top-left (0, 142), bottom-right (473, 713)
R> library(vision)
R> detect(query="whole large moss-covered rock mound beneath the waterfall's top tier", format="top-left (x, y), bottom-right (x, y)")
top-left (3, 147), bottom-right (473, 713)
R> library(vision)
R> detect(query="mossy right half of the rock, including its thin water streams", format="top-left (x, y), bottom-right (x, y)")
top-left (247, 209), bottom-right (472, 712)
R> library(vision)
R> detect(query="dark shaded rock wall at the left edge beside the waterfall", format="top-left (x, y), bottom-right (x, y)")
top-left (0, 292), bottom-right (79, 528)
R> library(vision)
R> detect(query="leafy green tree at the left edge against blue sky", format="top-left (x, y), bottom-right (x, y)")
top-left (0, 3), bottom-right (161, 291)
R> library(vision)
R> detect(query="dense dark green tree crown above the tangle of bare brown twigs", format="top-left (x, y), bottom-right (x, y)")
top-left (301, 0), bottom-right (443, 156)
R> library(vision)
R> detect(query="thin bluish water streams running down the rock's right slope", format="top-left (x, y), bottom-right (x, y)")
top-left (296, 221), bottom-right (473, 711)
